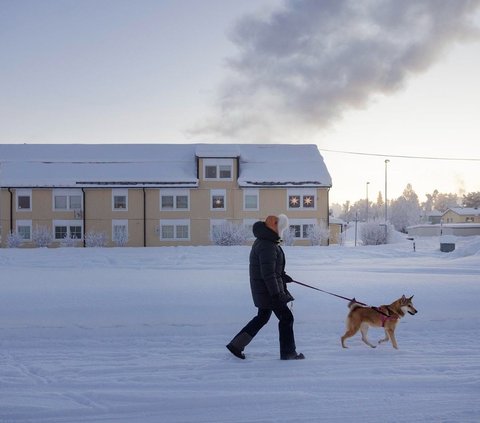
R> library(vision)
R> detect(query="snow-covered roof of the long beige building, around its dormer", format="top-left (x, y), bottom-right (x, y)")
top-left (0, 144), bottom-right (332, 187)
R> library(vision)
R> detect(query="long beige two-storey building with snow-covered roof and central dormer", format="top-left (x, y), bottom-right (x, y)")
top-left (0, 144), bottom-right (332, 247)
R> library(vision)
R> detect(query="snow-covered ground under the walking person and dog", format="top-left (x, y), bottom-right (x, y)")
top-left (0, 237), bottom-right (480, 423)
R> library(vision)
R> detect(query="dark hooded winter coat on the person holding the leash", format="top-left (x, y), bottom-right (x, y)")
top-left (250, 222), bottom-right (293, 308)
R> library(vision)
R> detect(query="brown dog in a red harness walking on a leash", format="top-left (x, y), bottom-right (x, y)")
top-left (341, 295), bottom-right (417, 349)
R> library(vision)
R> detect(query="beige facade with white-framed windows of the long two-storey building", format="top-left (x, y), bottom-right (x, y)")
top-left (0, 147), bottom-right (330, 247)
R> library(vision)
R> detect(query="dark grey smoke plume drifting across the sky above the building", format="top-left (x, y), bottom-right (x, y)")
top-left (196, 0), bottom-right (480, 142)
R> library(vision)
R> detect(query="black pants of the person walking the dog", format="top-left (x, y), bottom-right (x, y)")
top-left (239, 305), bottom-right (296, 355)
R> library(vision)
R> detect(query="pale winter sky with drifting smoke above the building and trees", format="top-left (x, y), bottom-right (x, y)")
top-left (0, 0), bottom-right (480, 203)
